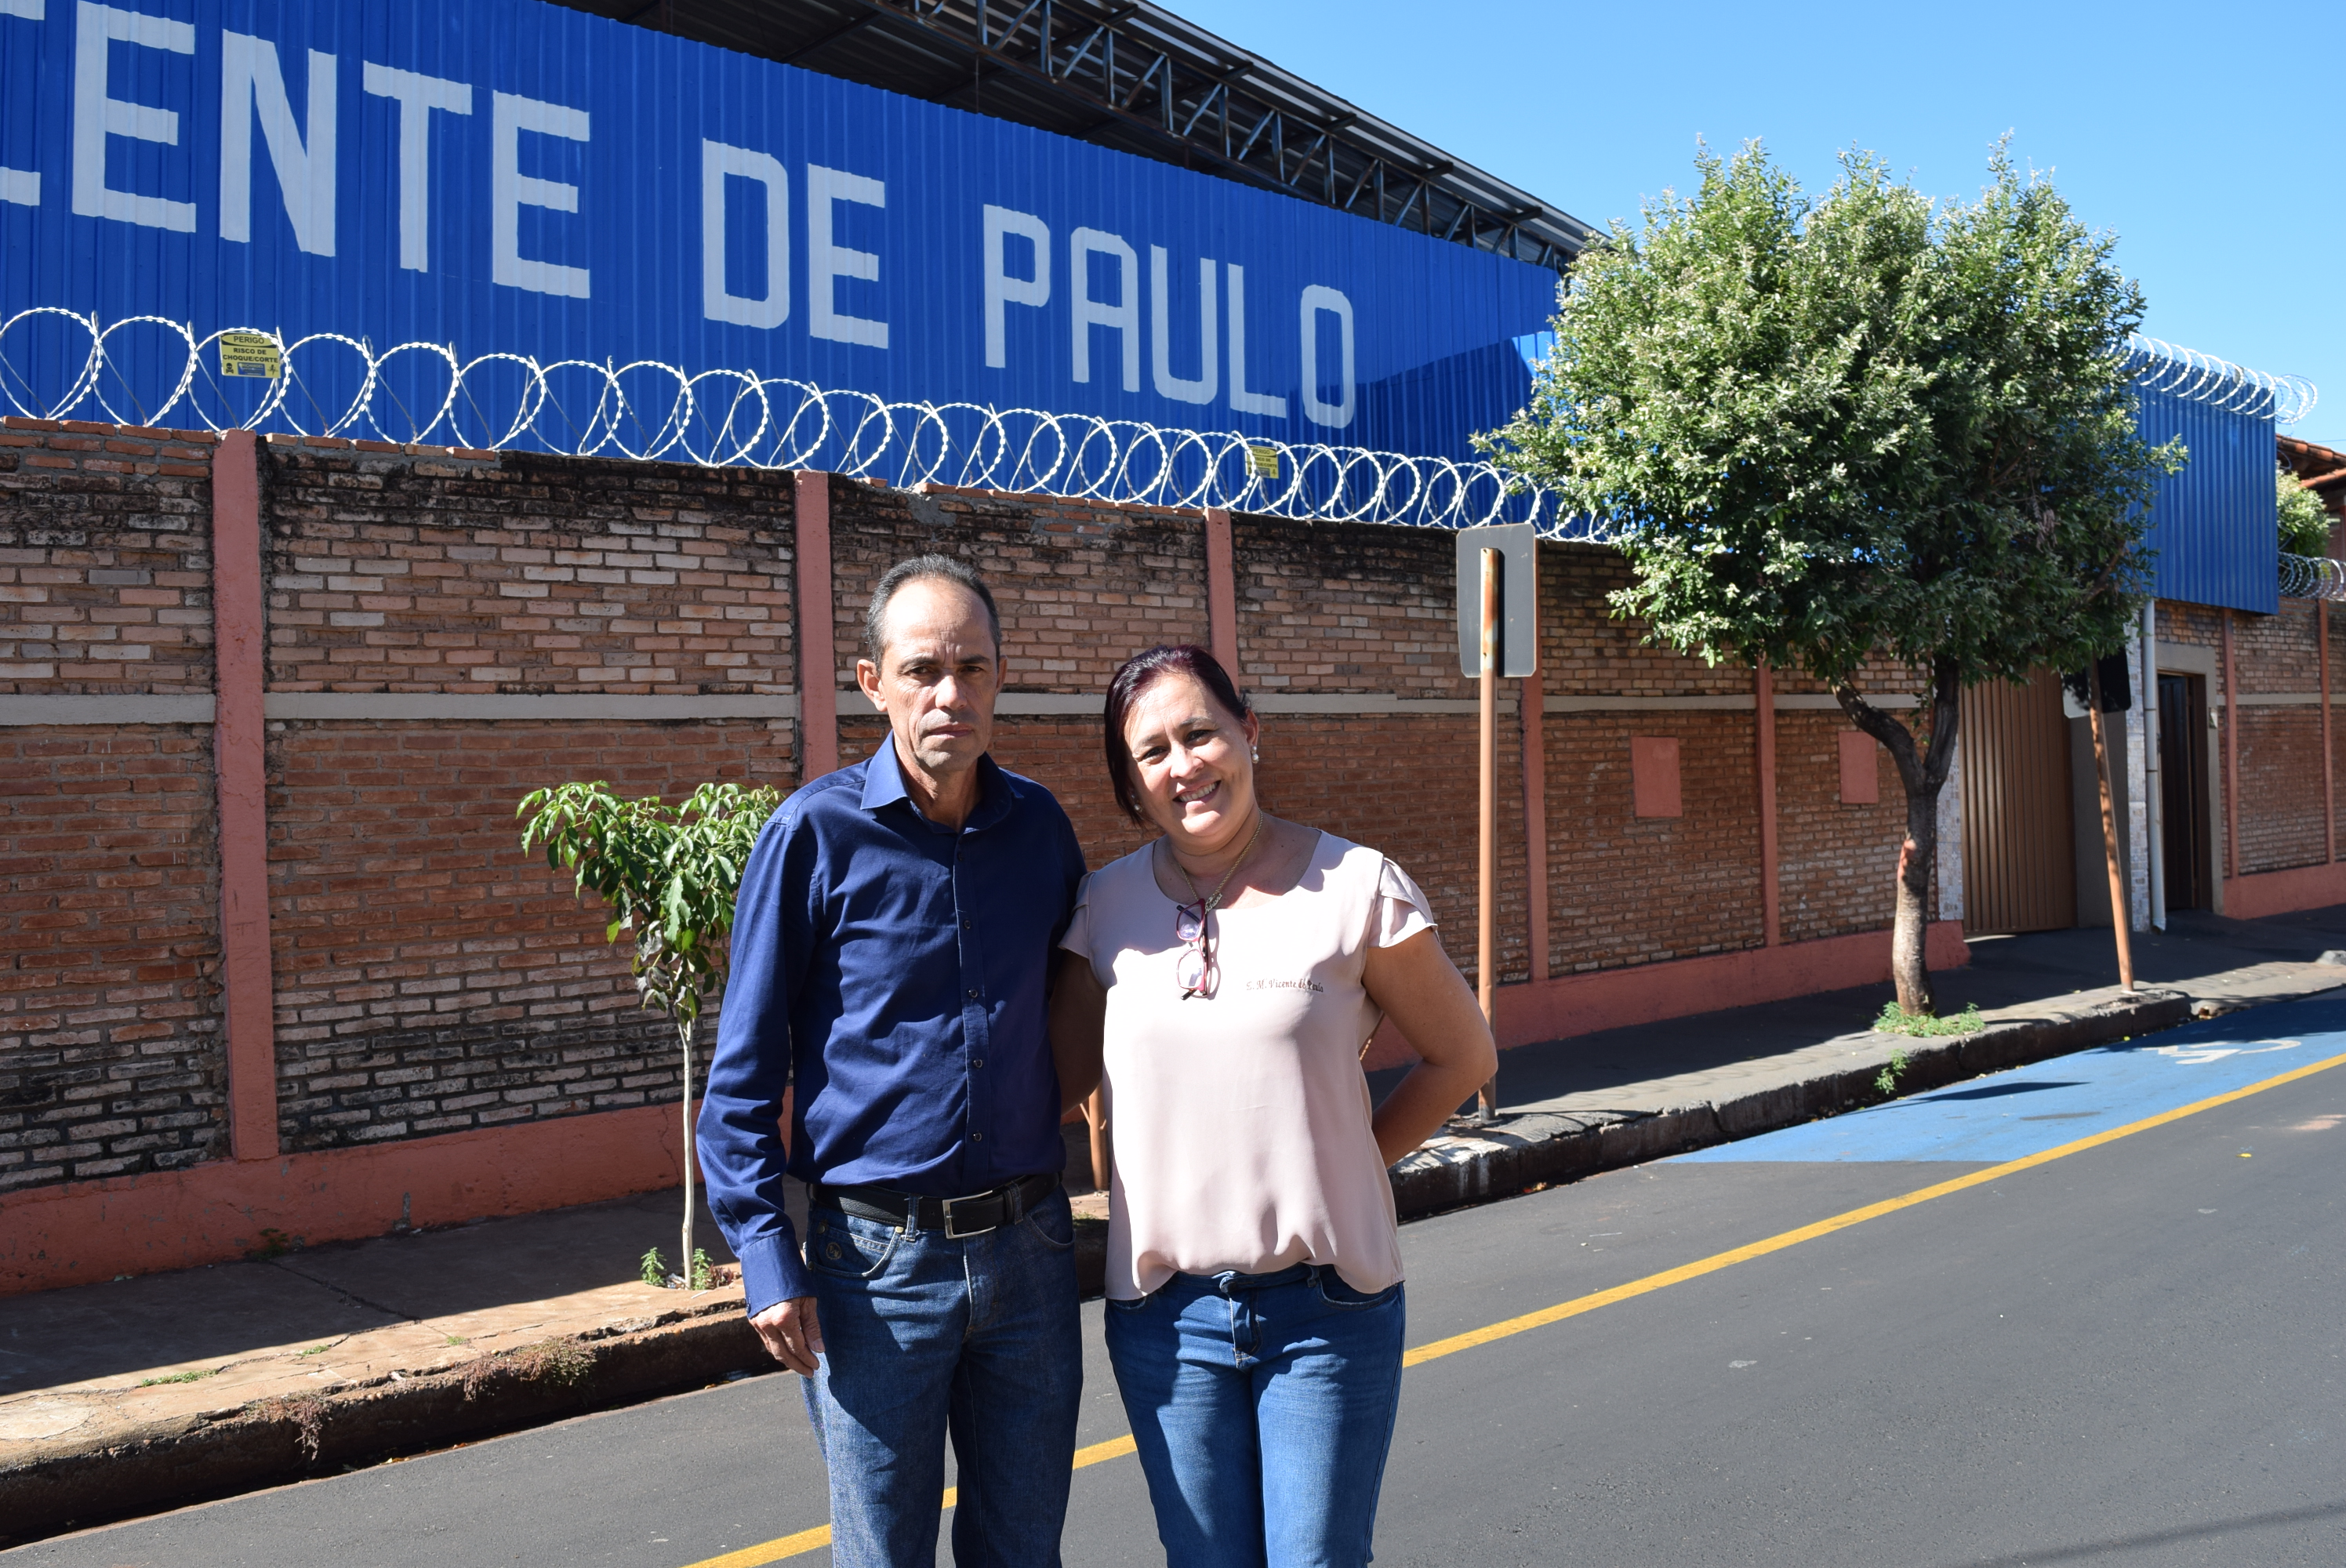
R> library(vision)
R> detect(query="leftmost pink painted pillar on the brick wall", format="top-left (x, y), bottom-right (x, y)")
top-left (211, 430), bottom-right (277, 1160)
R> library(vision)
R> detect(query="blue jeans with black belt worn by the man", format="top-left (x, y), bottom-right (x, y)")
top-left (807, 1192), bottom-right (1084, 1568)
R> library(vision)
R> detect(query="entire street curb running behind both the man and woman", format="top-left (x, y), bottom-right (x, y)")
top-left (0, 990), bottom-right (2228, 1547)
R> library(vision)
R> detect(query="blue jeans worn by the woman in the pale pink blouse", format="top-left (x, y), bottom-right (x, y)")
top-left (1107, 1263), bottom-right (1405, 1568)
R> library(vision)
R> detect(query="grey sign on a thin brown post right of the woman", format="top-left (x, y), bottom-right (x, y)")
top-left (1457, 524), bottom-right (1542, 1127)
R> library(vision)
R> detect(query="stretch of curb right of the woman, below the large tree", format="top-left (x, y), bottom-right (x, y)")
top-left (1393, 988), bottom-right (2194, 1221)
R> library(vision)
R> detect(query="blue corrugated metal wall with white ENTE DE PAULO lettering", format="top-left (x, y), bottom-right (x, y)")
top-left (0, 0), bottom-right (1556, 458)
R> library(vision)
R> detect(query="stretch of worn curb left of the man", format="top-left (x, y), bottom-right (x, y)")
top-left (0, 1301), bottom-right (774, 1547)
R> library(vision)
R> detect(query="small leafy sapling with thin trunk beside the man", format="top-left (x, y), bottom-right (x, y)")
top-left (514, 779), bottom-right (781, 1287)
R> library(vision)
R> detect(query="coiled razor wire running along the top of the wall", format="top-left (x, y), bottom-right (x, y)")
top-left (0, 305), bottom-right (2318, 539)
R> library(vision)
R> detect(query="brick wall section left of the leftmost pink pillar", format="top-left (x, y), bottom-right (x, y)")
top-left (0, 420), bottom-right (225, 1190)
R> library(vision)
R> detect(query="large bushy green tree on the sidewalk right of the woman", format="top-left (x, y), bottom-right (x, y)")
top-left (1483, 143), bottom-right (2182, 1014)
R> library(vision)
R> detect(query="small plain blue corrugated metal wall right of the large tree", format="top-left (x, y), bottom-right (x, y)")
top-left (2135, 392), bottom-right (2280, 615)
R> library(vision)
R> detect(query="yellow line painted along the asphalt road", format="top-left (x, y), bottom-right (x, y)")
top-left (685, 1054), bottom-right (2346, 1568)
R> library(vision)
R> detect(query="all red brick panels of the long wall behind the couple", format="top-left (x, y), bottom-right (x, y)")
top-left (13, 420), bottom-right (2320, 1190)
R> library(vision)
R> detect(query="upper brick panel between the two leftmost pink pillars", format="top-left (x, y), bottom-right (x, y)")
top-left (263, 437), bottom-right (795, 695)
